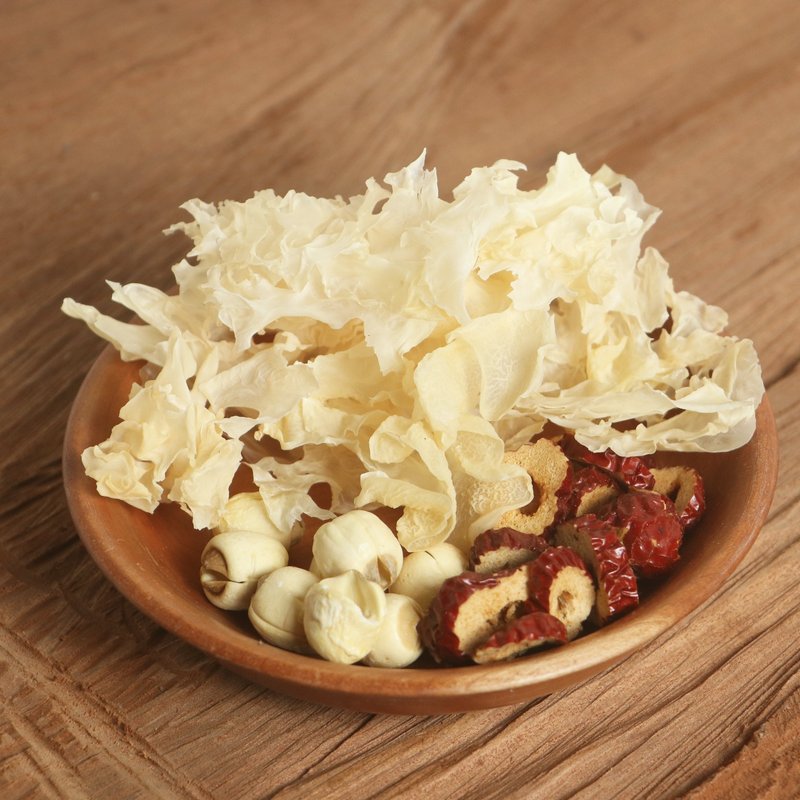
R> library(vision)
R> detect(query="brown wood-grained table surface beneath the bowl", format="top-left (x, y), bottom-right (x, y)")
top-left (0, 0), bottom-right (800, 800)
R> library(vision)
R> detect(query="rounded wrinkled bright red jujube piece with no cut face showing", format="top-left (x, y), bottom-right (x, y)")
top-left (608, 492), bottom-right (683, 578)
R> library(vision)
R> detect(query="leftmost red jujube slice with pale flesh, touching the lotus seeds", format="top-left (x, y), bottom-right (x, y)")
top-left (417, 564), bottom-right (529, 664)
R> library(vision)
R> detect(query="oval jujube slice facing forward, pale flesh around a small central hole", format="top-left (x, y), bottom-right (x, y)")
top-left (529, 547), bottom-right (595, 639)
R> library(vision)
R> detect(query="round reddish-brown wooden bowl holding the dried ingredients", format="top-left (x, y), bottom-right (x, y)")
top-left (64, 348), bottom-right (778, 714)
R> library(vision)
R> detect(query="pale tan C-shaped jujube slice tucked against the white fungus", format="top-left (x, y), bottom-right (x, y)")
top-left (498, 439), bottom-right (572, 534)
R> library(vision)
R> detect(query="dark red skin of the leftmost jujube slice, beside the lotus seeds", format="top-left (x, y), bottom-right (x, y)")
top-left (417, 570), bottom-right (528, 665)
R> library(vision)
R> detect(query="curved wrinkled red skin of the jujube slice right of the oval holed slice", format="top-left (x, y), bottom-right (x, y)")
top-left (555, 514), bottom-right (639, 625)
